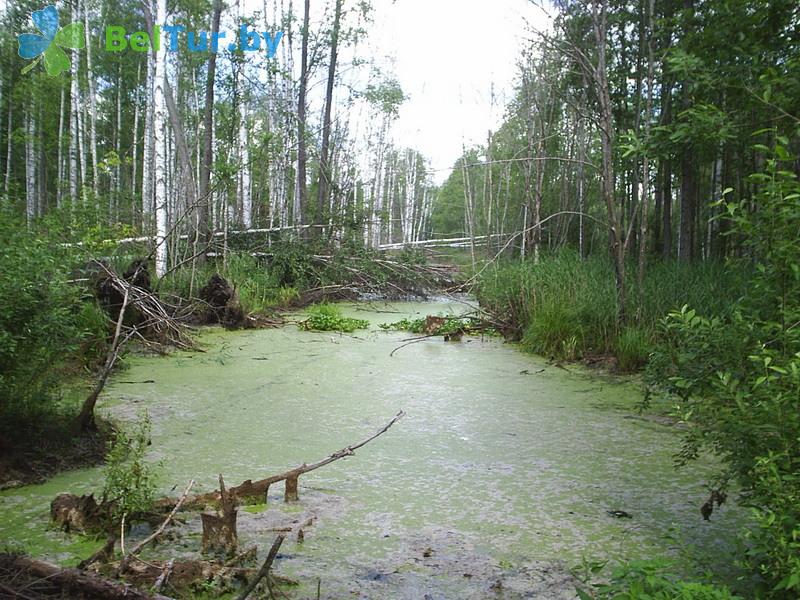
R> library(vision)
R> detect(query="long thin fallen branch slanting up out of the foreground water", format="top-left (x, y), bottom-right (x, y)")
top-left (155, 410), bottom-right (405, 511)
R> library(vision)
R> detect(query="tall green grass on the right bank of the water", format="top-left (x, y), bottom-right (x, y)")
top-left (477, 251), bottom-right (747, 371)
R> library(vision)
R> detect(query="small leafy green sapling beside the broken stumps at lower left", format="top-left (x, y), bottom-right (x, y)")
top-left (103, 412), bottom-right (157, 522)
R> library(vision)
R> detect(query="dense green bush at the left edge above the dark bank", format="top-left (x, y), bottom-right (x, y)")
top-left (0, 211), bottom-right (93, 422)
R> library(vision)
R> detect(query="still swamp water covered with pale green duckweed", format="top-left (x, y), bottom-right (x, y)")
top-left (0, 302), bottom-right (741, 599)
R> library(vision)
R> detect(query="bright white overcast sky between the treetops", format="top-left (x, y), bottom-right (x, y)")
top-left (369, 0), bottom-right (545, 183)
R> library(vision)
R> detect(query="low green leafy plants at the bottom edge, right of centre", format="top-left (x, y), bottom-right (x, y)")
top-left (578, 560), bottom-right (742, 600)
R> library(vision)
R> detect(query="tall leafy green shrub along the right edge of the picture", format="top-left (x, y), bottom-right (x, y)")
top-left (647, 146), bottom-right (800, 598)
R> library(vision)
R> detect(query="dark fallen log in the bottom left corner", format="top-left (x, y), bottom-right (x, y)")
top-left (0, 555), bottom-right (170, 600)
